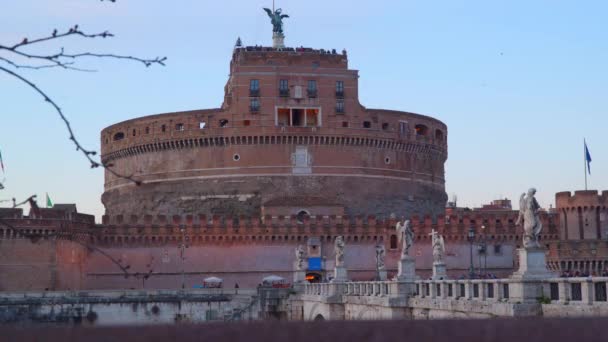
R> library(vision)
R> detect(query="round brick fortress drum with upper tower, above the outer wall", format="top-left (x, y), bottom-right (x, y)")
top-left (101, 48), bottom-right (447, 216)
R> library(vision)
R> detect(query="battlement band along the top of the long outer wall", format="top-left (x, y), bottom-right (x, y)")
top-left (96, 212), bottom-right (557, 243)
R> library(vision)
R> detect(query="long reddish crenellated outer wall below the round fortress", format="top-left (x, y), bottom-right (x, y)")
top-left (0, 208), bottom-right (557, 290)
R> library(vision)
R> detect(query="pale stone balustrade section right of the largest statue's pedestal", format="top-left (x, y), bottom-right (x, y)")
top-left (544, 277), bottom-right (608, 305)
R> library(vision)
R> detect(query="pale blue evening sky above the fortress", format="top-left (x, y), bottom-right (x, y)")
top-left (0, 0), bottom-right (608, 220)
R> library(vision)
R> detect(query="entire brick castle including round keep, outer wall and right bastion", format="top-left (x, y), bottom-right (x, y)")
top-left (0, 12), bottom-right (608, 291)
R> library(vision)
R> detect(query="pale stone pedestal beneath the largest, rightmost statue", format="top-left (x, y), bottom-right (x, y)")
top-left (509, 247), bottom-right (557, 303)
